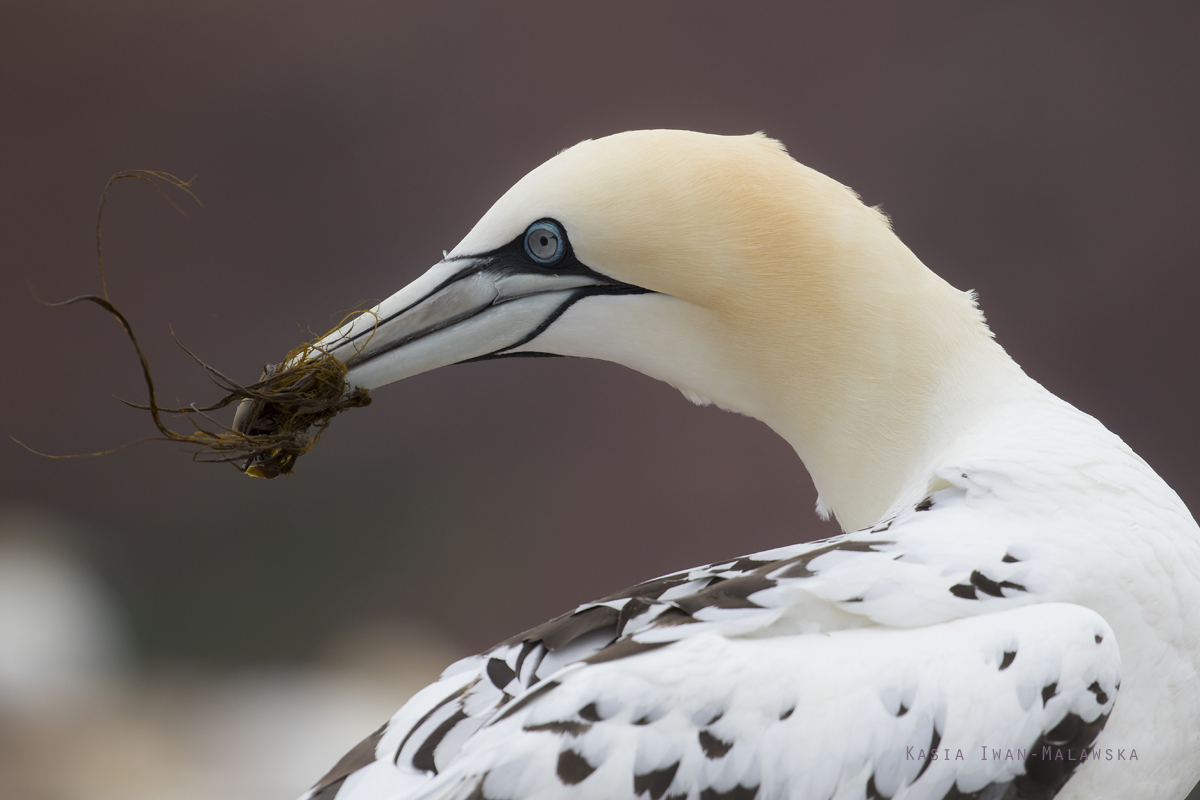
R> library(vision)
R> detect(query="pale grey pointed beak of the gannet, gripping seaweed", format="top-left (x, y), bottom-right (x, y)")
top-left (322, 253), bottom-right (644, 389)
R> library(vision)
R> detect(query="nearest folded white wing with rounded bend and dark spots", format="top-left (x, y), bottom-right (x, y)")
top-left (317, 603), bottom-right (1121, 800)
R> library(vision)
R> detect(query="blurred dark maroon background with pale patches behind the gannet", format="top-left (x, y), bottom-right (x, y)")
top-left (0, 0), bottom-right (1200, 800)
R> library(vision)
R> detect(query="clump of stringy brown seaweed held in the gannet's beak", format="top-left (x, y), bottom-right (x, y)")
top-left (18, 169), bottom-right (371, 479)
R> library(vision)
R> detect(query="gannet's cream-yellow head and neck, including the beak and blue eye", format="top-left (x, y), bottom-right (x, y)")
top-left (314, 131), bottom-right (1010, 529)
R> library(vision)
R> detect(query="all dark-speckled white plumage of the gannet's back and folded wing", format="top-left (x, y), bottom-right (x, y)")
top-left (306, 467), bottom-right (1121, 800)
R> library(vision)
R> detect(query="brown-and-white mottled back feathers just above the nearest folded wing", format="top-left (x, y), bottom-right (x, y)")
top-left (304, 470), bottom-right (1090, 800)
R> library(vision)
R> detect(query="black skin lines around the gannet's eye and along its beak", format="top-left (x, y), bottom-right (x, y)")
top-left (337, 218), bottom-right (653, 367)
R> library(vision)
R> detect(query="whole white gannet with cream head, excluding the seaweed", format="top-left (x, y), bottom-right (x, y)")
top-left (292, 131), bottom-right (1200, 800)
